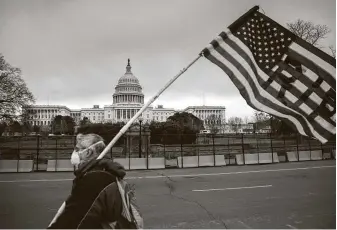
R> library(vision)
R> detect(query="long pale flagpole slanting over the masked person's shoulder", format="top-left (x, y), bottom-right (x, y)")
top-left (49, 53), bottom-right (203, 226)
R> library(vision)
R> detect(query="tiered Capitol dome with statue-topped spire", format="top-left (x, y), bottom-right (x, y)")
top-left (113, 59), bottom-right (144, 104)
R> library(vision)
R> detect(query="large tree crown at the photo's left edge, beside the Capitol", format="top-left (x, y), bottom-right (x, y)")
top-left (0, 54), bottom-right (35, 120)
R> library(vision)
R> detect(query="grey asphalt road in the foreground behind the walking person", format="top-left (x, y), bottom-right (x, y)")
top-left (0, 160), bottom-right (336, 229)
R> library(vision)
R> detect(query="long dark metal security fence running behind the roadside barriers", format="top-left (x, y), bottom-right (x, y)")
top-left (0, 134), bottom-right (336, 171)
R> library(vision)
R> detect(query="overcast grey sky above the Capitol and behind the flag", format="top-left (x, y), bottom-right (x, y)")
top-left (0, 0), bottom-right (336, 117)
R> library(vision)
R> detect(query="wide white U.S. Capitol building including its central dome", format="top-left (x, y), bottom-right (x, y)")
top-left (26, 60), bottom-right (226, 129)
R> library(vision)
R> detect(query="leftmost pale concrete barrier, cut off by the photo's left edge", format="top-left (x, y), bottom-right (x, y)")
top-left (0, 160), bottom-right (33, 172)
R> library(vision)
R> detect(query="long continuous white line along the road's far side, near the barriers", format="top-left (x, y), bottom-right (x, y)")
top-left (0, 165), bottom-right (336, 183)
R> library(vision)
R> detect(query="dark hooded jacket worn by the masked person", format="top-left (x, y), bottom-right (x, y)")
top-left (48, 159), bottom-right (137, 229)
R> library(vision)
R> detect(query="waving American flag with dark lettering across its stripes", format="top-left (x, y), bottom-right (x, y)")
top-left (202, 6), bottom-right (336, 143)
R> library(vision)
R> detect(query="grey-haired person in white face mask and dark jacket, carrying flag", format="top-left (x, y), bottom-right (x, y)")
top-left (48, 134), bottom-right (143, 229)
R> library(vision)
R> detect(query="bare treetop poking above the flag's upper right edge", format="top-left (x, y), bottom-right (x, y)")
top-left (287, 19), bottom-right (331, 48)
